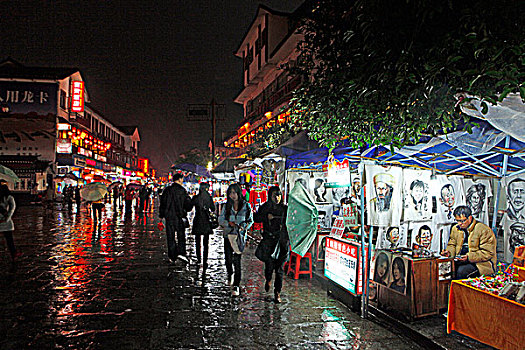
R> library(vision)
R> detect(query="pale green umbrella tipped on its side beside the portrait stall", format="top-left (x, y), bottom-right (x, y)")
top-left (286, 182), bottom-right (319, 256)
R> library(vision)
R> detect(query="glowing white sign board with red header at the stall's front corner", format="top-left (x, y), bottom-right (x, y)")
top-left (324, 237), bottom-right (363, 295)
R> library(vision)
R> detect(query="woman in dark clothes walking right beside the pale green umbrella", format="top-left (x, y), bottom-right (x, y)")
top-left (254, 186), bottom-right (290, 303)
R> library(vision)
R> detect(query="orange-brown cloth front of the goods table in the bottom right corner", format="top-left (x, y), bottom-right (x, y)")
top-left (447, 281), bottom-right (525, 350)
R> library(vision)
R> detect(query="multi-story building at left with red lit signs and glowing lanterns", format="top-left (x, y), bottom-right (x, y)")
top-left (0, 59), bottom-right (145, 200)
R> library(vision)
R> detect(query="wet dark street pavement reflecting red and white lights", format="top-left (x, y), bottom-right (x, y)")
top-left (0, 203), bottom-right (428, 349)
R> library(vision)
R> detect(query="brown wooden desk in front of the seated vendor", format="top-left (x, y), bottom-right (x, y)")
top-left (377, 255), bottom-right (454, 319)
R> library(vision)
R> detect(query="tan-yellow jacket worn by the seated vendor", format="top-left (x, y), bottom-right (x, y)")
top-left (447, 219), bottom-right (497, 275)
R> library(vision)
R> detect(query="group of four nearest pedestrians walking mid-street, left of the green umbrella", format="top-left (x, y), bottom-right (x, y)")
top-left (159, 178), bottom-right (289, 303)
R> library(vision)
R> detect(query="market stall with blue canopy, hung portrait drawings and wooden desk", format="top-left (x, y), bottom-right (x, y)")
top-left (286, 117), bottom-right (525, 318)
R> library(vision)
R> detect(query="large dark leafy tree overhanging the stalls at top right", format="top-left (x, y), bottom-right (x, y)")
top-left (289, 0), bottom-right (525, 147)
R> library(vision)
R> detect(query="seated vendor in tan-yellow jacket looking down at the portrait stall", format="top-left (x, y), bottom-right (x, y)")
top-left (441, 205), bottom-right (497, 279)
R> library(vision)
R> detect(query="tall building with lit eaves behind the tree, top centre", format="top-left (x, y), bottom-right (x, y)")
top-left (224, 5), bottom-right (302, 155)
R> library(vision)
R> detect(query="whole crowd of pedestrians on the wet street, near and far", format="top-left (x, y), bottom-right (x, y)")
top-left (0, 174), bottom-right (289, 303)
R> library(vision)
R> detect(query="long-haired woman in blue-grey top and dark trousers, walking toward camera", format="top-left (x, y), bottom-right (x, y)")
top-left (215, 184), bottom-right (253, 296)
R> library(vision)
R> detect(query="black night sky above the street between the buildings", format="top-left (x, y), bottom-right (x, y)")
top-left (0, 0), bottom-right (303, 172)
